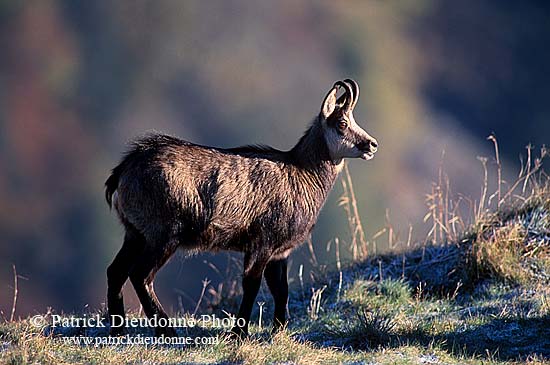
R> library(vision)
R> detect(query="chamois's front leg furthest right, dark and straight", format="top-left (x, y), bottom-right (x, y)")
top-left (264, 258), bottom-right (288, 332)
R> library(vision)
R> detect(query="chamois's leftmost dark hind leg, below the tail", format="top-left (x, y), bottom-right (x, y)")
top-left (107, 228), bottom-right (145, 336)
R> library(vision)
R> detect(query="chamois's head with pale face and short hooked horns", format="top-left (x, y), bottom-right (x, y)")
top-left (319, 79), bottom-right (378, 163)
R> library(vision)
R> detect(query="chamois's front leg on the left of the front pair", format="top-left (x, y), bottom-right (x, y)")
top-left (231, 253), bottom-right (268, 338)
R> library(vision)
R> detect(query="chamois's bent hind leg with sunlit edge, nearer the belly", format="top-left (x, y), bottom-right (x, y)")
top-left (130, 242), bottom-right (177, 337)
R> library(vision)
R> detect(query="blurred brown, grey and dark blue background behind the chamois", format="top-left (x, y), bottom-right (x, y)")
top-left (0, 0), bottom-right (550, 317)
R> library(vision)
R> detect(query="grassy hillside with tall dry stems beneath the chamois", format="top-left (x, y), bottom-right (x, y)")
top-left (0, 149), bottom-right (550, 364)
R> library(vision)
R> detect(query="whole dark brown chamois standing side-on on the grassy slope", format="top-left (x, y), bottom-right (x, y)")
top-left (105, 79), bottom-right (378, 336)
